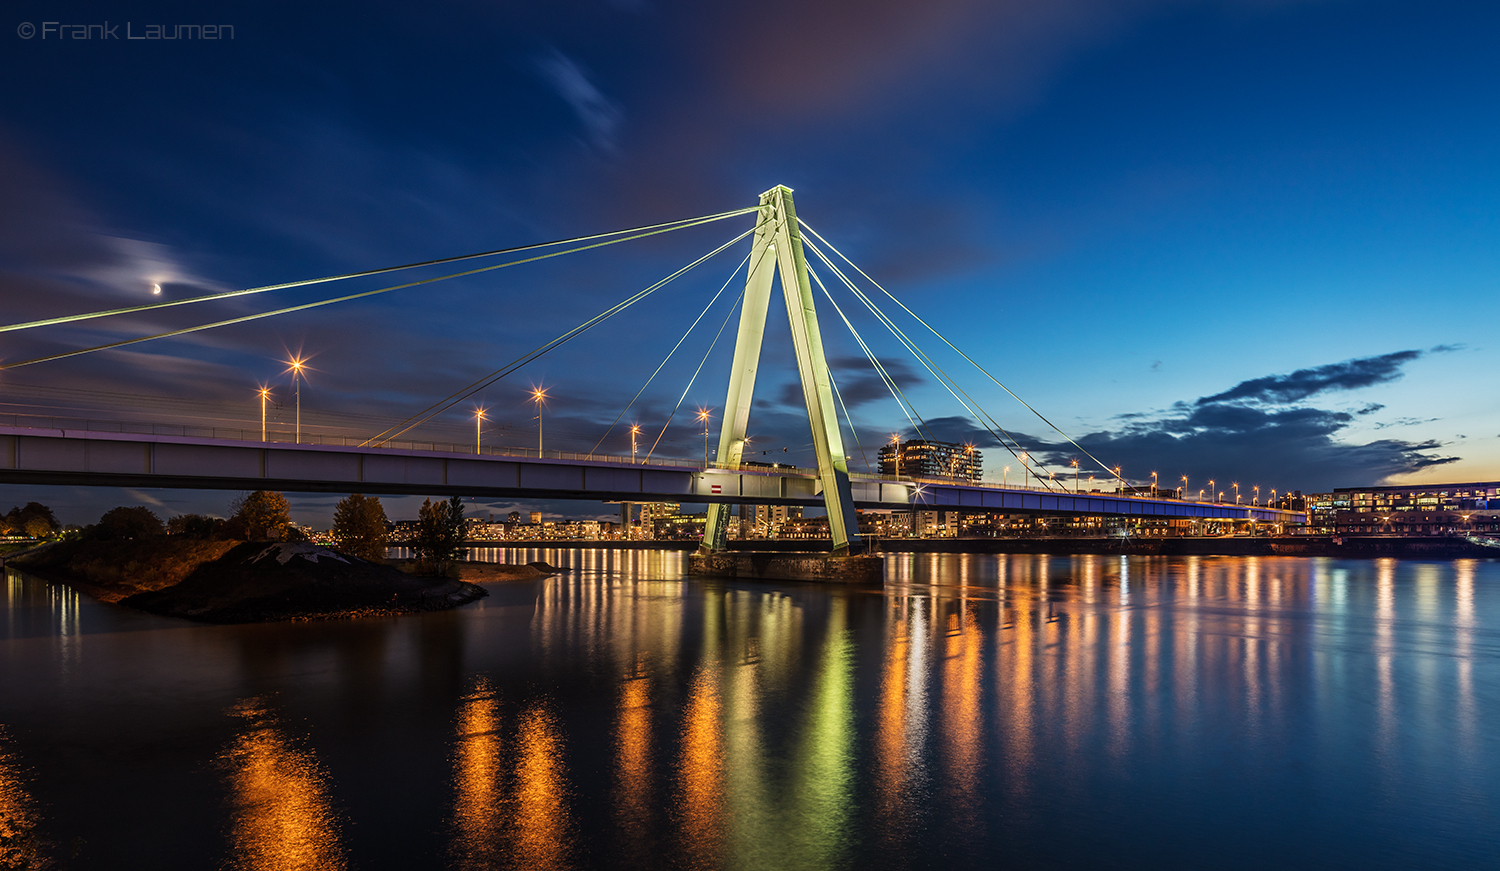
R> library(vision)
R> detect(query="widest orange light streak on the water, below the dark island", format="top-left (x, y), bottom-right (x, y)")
top-left (221, 699), bottom-right (348, 871)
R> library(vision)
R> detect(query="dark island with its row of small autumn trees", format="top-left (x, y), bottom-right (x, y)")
top-left (2, 490), bottom-right (554, 624)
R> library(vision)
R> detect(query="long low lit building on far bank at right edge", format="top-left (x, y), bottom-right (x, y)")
top-left (1332, 481), bottom-right (1500, 535)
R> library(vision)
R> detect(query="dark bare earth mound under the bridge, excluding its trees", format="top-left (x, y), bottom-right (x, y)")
top-left (17, 538), bottom-right (489, 624)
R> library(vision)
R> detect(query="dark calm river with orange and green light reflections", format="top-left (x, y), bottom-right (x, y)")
top-left (0, 550), bottom-right (1500, 871)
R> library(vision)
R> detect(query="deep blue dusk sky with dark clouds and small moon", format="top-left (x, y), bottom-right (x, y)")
top-left (0, 0), bottom-right (1500, 523)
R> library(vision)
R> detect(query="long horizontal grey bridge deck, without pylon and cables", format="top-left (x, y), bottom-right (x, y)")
top-left (0, 426), bottom-right (1301, 522)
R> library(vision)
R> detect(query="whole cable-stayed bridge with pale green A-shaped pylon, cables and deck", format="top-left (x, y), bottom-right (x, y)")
top-left (0, 186), bottom-right (1302, 553)
